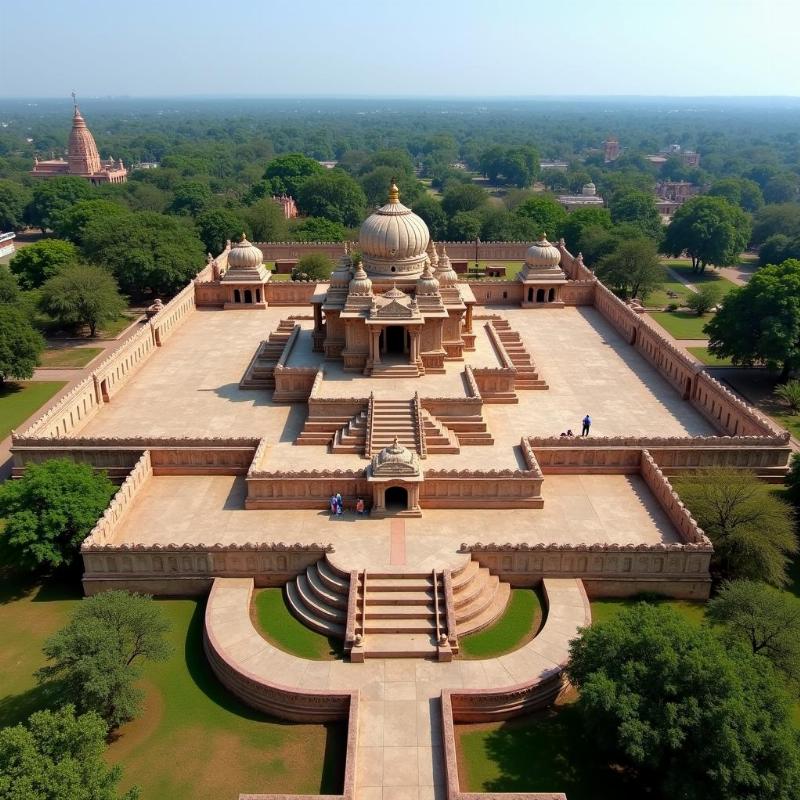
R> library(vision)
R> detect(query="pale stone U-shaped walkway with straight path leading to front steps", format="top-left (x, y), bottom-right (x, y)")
top-left (205, 578), bottom-right (591, 800)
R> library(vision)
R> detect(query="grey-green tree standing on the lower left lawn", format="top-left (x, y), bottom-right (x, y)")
top-left (37, 590), bottom-right (171, 729)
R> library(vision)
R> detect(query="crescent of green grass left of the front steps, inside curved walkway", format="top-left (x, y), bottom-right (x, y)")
top-left (252, 589), bottom-right (343, 661)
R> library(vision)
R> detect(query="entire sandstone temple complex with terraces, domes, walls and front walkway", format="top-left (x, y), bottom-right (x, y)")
top-left (13, 180), bottom-right (790, 800)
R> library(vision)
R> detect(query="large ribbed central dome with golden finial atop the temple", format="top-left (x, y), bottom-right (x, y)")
top-left (358, 183), bottom-right (431, 279)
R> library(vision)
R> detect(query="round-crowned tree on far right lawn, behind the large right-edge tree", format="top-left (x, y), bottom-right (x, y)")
top-left (663, 196), bottom-right (750, 272)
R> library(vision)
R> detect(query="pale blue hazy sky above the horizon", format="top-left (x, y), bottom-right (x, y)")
top-left (0, 0), bottom-right (800, 97)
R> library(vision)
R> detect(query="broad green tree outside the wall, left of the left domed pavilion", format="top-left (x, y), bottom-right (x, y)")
top-left (83, 211), bottom-right (206, 298)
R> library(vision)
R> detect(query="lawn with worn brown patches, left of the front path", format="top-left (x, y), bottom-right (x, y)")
top-left (0, 576), bottom-right (345, 800)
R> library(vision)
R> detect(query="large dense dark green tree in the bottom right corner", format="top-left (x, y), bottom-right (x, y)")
top-left (567, 603), bottom-right (800, 800)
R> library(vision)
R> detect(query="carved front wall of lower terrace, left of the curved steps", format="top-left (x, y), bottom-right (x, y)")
top-left (81, 542), bottom-right (333, 595)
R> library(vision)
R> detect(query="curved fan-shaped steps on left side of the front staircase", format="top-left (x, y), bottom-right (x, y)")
top-left (286, 558), bottom-right (350, 639)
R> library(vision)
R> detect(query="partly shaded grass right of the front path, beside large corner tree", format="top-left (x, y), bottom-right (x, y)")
top-left (456, 706), bottom-right (641, 800)
